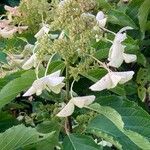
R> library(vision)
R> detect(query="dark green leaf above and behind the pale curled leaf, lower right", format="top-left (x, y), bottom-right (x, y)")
top-left (96, 95), bottom-right (150, 139)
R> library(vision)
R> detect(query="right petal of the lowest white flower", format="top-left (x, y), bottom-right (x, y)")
top-left (71, 95), bottom-right (95, 108)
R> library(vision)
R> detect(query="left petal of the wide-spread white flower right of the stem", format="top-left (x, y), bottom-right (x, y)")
top-left (90, 73), bottom-right (112, 91)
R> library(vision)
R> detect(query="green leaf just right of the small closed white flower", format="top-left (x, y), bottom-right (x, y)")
top-left (108, 10), bottom-right (137, 29)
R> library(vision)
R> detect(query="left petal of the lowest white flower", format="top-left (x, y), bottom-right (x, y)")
top-left (56, 101), bottom-right (75, 117)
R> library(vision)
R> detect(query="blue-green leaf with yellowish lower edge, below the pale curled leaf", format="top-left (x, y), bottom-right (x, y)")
top-left (87, 115), bottom-right (138, 150)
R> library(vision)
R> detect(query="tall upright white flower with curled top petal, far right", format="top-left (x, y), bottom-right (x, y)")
top-left (108, 27), bottom-right (137, 68)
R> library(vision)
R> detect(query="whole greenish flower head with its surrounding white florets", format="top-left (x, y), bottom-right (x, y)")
top-left (22, 0), bottom-right (137, 117)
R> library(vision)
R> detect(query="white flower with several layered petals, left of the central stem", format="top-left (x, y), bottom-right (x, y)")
top-left (23, 70), bottom-right (65, 96)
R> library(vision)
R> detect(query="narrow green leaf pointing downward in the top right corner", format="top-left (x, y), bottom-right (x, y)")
top-left (138, 0), bottom-right (150, 35)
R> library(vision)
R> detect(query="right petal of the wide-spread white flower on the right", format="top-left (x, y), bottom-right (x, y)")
top-left (114, 71), bottom-right (134, 84)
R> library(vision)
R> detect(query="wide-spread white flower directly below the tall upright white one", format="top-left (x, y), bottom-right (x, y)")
top-left (90, 71), bottom-right (134, 91)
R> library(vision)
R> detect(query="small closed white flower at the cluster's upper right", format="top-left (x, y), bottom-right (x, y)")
top-left (96, 11), bottom-right (107, 28)
